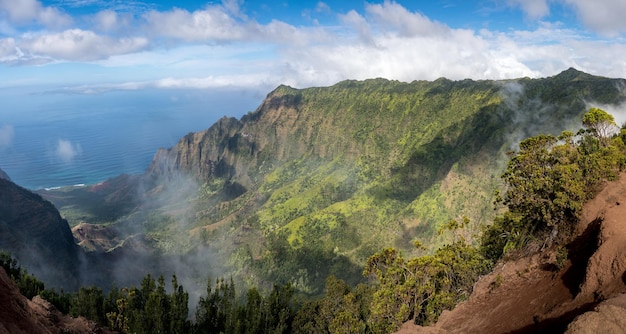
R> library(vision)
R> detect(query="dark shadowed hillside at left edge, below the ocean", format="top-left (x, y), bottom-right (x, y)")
top-left (0, 179), bottom-right (80, 289)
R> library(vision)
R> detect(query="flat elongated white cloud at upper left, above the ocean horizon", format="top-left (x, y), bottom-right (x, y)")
top-left (19, 29), bottom-right (148, 61)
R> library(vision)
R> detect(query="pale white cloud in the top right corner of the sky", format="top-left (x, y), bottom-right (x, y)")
top-left (564, 0), bottom-right (626, 36)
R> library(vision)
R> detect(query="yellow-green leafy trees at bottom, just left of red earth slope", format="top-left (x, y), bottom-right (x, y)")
top-left (364, 241), bottom-right (491, 333)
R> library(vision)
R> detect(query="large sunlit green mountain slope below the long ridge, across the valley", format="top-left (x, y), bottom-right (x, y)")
top-left (42, 69), bottom-right (624, 293)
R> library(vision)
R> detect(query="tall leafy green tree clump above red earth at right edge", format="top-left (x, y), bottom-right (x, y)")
top-left (481, 108), bottom-right (626, 260)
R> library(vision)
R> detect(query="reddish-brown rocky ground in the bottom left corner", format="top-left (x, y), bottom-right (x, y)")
top-left (0, 268), bottom-right (112, 334)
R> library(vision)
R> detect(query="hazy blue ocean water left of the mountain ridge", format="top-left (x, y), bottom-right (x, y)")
top-left (0, 89), bottom-right (263, 189)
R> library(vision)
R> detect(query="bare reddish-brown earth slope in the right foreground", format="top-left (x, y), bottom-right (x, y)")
top-left (400, 174), bottom-right (626, 334)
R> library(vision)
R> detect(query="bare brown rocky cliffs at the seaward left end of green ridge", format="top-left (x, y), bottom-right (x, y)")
top-left (147, 86), bottom-right (316, 191)
